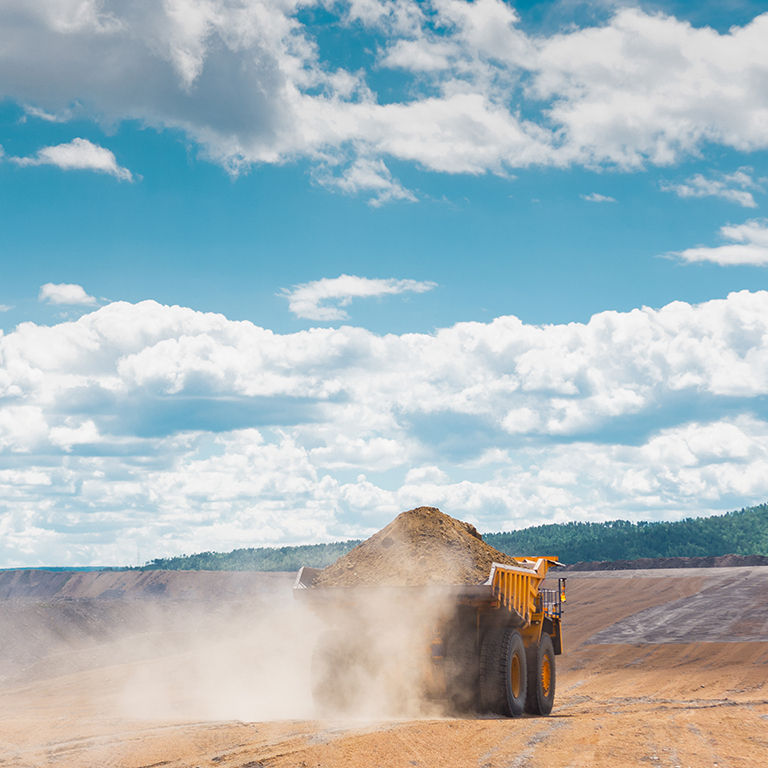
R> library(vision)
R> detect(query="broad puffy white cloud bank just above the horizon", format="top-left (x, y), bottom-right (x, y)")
top-left (0, 291), bottom-right (768, 565)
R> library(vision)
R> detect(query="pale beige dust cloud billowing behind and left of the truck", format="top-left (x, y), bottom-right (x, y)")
top-left (0, 574), bottom-right (462, 722)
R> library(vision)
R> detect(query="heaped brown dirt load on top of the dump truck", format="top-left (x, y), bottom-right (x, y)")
top-left (313, 507), bottom-right (516, 587)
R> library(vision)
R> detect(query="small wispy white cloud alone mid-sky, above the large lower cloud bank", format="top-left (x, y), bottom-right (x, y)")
top-left (281, 275), bottom-right (436, 321)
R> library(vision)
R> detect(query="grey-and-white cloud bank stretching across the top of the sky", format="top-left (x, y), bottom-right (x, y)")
top-left (0, 0), bottom-right (768, 196)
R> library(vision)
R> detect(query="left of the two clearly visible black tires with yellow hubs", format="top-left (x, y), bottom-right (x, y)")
top-left (480, 627), bottom-right (528, 717)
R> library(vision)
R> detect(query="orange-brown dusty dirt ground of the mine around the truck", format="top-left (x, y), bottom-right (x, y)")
top-left (0, 568), bottom-right (768, 768)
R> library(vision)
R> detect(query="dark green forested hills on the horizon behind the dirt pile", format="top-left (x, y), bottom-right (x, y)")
top-left (143, 504), bottom-right (768, 571)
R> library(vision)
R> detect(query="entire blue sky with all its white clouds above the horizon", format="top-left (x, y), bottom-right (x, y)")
top-left (0, 0), bottom-right (768, 566)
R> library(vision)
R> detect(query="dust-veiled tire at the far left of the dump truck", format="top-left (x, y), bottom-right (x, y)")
top-left (311, 629), bottom-right (361, 716)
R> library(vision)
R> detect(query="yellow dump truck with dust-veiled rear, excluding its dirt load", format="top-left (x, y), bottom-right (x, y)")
top-left (294, 557), bottom-right (565, 717)
